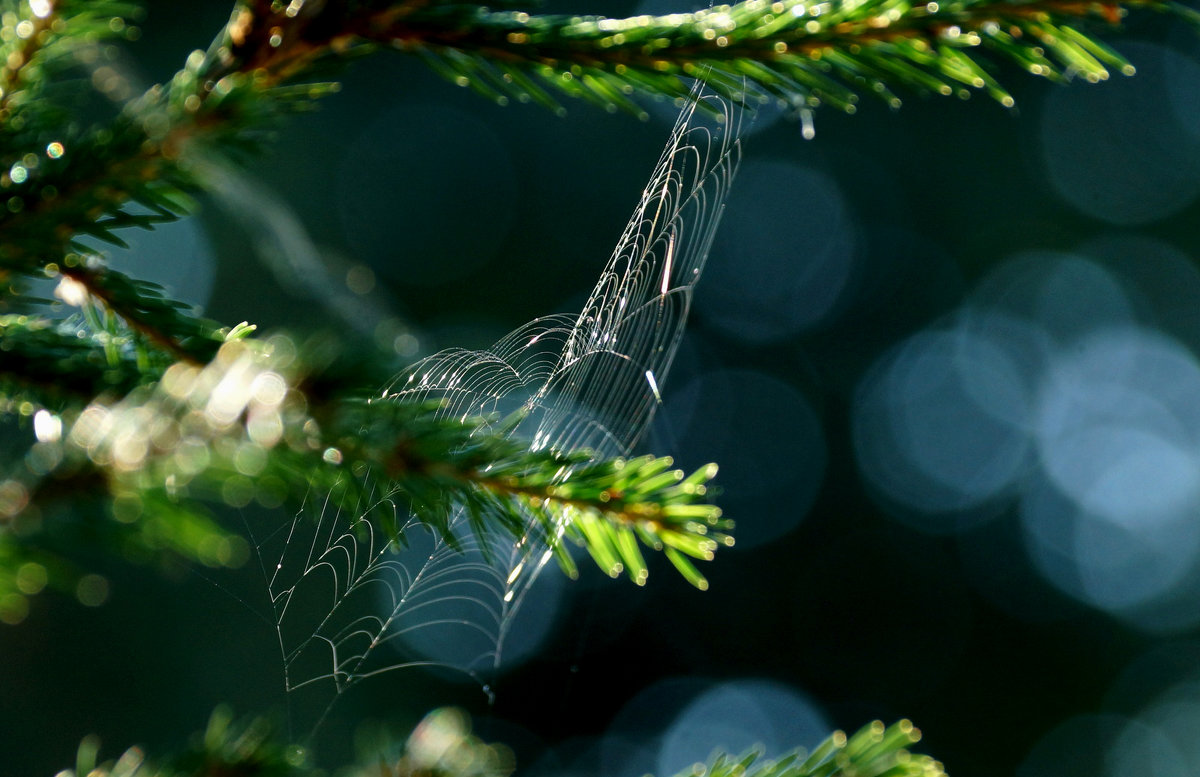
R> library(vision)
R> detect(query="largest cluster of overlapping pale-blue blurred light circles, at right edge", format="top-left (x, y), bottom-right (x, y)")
top-left (853, 250), bottom-right (1200, 632)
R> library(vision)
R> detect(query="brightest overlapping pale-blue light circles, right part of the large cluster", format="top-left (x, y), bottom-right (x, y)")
top-left (1020, 326), bottom-right (1200, 625)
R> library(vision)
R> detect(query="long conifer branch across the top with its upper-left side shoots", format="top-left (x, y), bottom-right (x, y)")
top-left (0, 0), bottom-right (1198, 363)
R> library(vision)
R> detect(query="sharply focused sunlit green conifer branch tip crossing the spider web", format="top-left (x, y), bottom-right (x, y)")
top-left (348, 403), bottom-right (733, 589)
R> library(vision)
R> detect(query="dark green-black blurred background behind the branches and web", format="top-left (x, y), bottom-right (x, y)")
top-left (0, 2), bottom-right (1200, 777)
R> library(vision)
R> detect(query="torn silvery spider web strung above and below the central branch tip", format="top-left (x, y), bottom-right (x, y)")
top-left (243, 88), bottom-right (740, 731)
